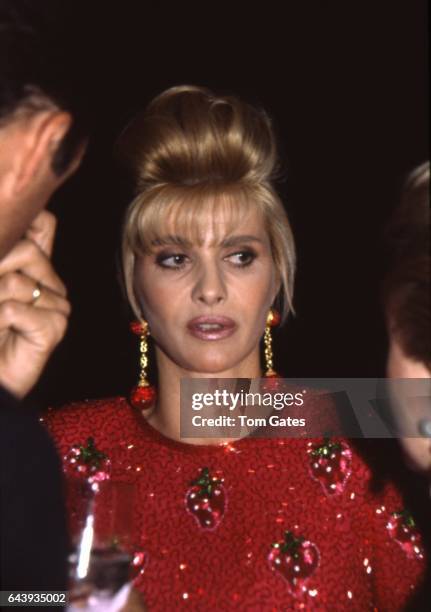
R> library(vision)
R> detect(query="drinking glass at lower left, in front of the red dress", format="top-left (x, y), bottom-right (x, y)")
top-left (66, 439), bottom-right (145, 612)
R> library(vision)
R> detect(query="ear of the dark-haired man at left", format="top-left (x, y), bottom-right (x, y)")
top-left (14, 110), bottom-right (72, 195)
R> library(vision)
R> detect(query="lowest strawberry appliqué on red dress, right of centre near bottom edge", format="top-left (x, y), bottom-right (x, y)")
top-left (268, 531), bottom-right (320, 597)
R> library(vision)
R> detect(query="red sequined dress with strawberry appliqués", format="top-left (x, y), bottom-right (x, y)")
top-left (44, 398), bottom-right (425, 612)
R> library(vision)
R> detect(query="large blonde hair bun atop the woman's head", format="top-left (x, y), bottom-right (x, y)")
top-left (117, 85), bottom-right (277, 193)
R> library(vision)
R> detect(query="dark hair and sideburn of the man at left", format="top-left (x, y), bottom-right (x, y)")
top-left (0, 0), bottom-right (91, 176)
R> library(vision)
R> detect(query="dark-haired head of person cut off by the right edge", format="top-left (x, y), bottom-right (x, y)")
top-left (383, 162), bottom-right (431, 470)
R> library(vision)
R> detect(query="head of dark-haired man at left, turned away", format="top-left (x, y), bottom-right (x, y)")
top-left (0, 0), bottom-right (89, 259)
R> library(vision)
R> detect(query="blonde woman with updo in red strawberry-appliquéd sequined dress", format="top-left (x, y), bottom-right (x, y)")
top-left (46, 86), bottom-right (424, 612)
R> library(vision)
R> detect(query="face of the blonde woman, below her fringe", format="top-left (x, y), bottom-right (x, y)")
top-left (134, 207), bottom-right (279, 377)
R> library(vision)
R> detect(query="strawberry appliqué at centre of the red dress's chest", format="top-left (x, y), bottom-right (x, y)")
top-left (185, 467), bottom-right (227, 531)
